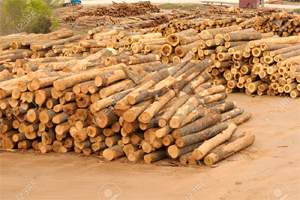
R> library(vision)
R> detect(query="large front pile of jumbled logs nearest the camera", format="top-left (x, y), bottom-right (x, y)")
top-left (0, 50), bottom-right (255, 165)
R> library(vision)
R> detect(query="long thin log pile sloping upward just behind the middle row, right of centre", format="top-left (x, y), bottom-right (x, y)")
top-left (134, 7), bottom-right (284, 36)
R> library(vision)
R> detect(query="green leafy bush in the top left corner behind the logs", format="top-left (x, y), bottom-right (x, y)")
top-left (0, 0), bottom-right (60, 35)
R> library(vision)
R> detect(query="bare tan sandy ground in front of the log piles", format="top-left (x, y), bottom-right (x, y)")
top-left (0, 94), bottom-right (300, 200)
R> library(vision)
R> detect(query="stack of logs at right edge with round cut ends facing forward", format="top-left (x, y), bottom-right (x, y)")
top-left (203, 29), bottom-right (300, 98)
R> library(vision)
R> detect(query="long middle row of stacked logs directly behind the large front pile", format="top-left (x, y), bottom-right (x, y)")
top-left (0, 14), bottom-right (300, 98)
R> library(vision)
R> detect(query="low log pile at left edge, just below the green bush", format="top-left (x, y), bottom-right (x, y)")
top-left (0, 29), bottom-right (82, 64)
